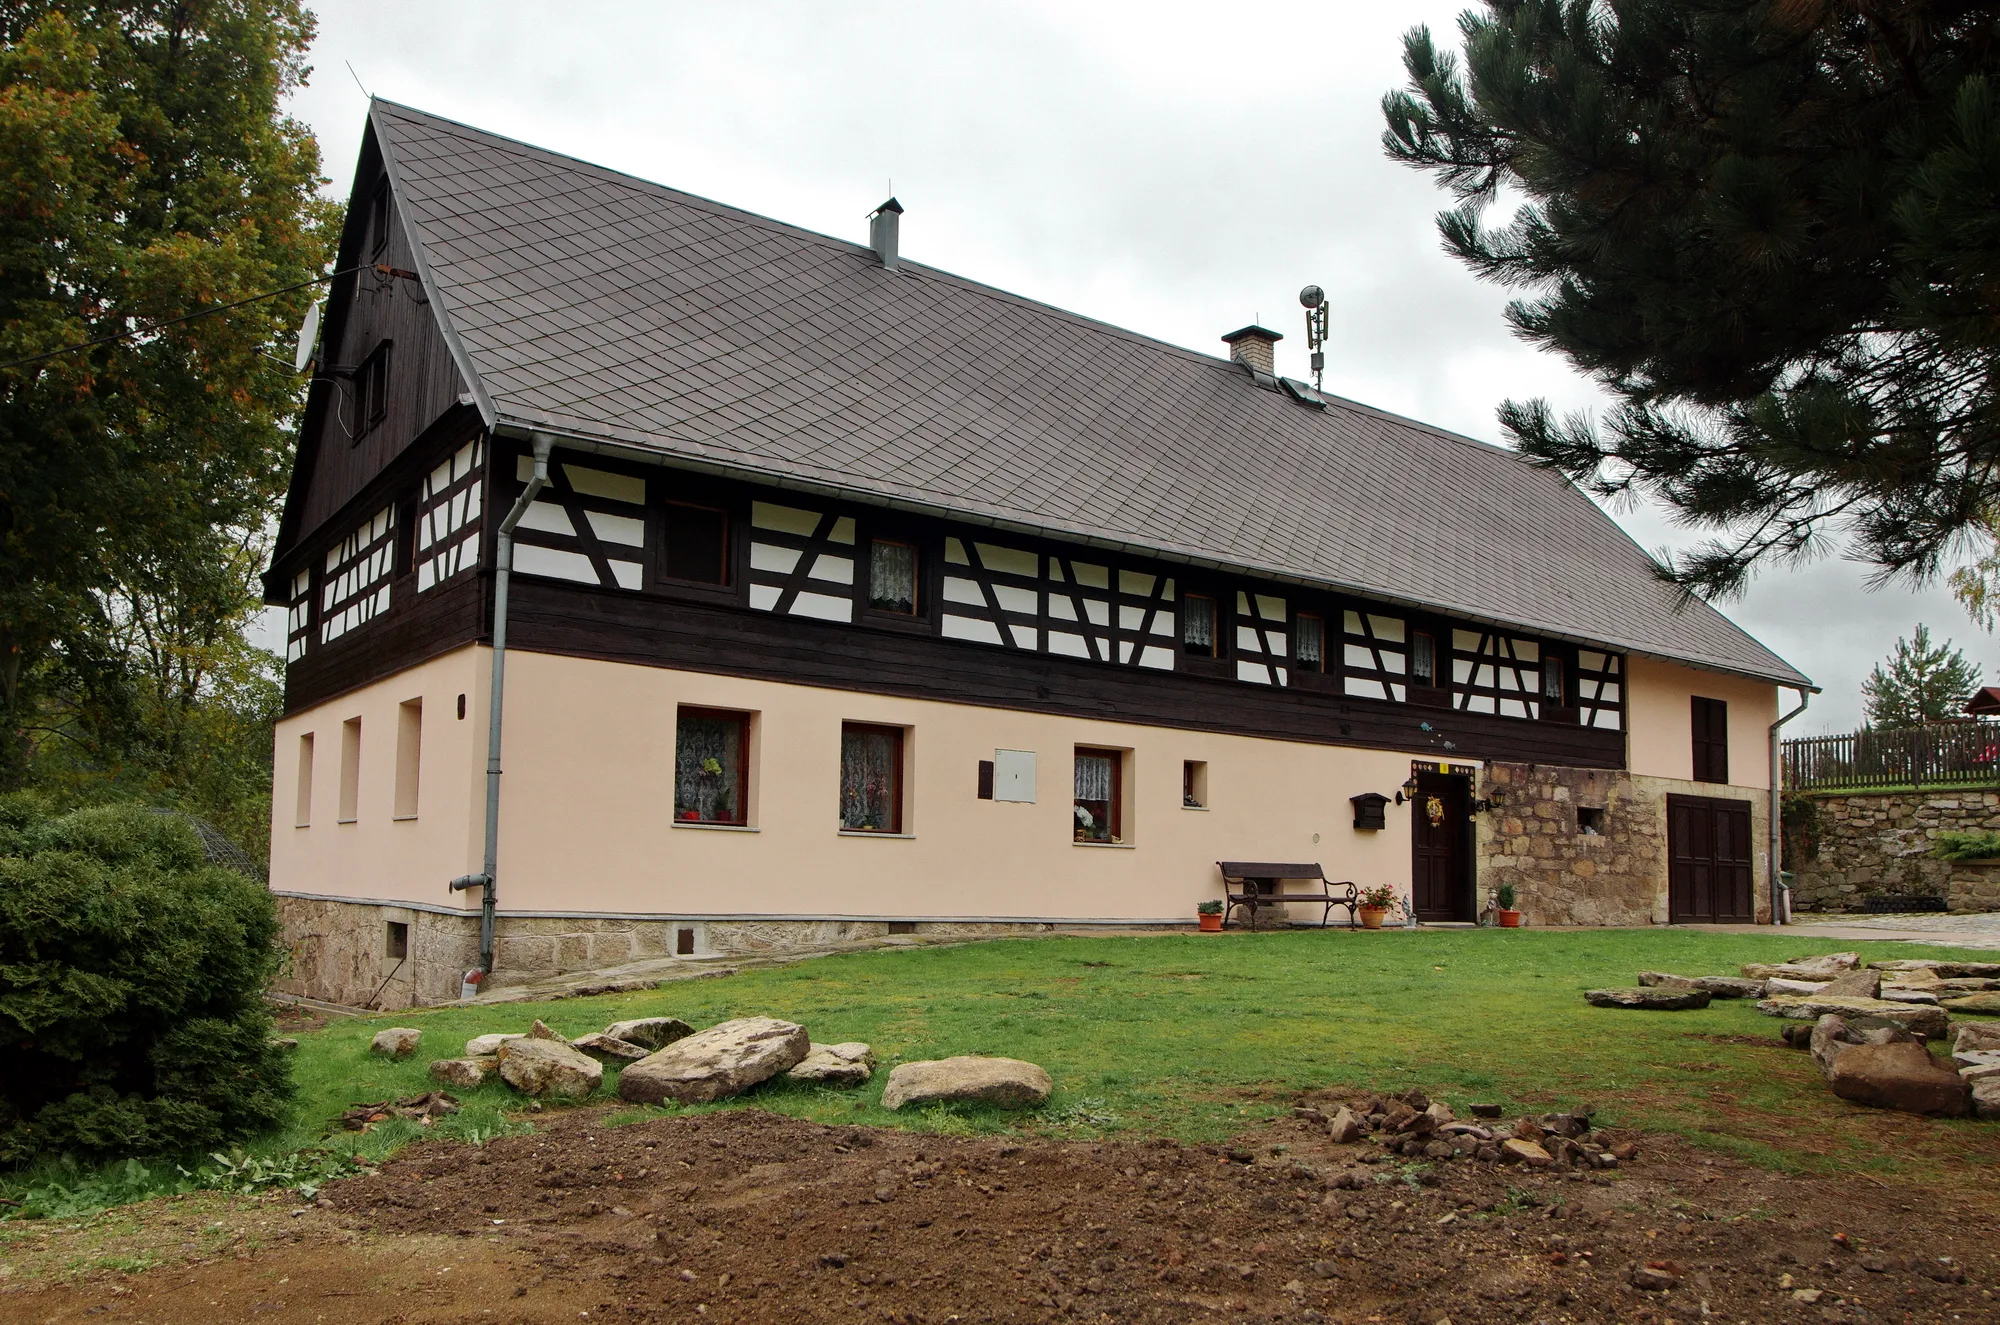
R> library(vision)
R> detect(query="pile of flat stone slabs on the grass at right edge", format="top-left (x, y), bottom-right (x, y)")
top-left (1584, 953), bottom-right (2000, 1119)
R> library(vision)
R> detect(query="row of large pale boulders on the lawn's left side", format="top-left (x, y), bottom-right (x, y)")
top-left (370, 1017), bottom-right (1052, 1109)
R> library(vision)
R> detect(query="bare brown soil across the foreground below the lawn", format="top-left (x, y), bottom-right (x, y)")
top-left (0, 1111), bottom-right (2000, 1325)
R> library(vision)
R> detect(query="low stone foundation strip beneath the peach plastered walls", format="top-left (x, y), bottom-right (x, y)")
top-left (274, 893), bottom-right (1056, 1009)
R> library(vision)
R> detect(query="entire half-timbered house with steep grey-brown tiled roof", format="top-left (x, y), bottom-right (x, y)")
top-left (266, 102), bottom-right (1810, 1005)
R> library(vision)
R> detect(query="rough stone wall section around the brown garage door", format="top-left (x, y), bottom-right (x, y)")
top-left (1476, 763), bottom-right (1770, 925)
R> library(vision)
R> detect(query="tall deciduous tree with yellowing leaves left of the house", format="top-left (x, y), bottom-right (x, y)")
top-left (0, 0), bottom-right (330, 808)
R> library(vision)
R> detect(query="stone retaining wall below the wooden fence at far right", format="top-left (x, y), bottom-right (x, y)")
top-left (1786, 791), bottom-right (2000, 913)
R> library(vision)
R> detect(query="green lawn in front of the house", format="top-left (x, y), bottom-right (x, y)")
top-left (270, 931), bottom-right (2000, 1181)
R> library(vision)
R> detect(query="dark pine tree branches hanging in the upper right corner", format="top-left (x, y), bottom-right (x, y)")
top-left (1382, 0), bottom-right (2000, 596)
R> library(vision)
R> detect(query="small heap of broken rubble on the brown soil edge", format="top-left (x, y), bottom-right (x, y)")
top-left (1292, 1091), bottom-right (1638, 1189)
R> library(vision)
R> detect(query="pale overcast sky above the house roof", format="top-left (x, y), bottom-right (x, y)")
top-left (278, 0), bottom-right (2000, 731)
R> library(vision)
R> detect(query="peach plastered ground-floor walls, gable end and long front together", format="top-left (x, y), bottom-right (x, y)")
top-left (272, 648), bottom-right (1412, 923)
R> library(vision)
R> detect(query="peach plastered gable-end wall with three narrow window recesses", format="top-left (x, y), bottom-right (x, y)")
top-left (270, 646), bottom-right (488, 907)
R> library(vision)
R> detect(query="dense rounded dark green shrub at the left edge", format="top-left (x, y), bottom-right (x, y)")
top-left (0, 797), bottom-right (292, 1165)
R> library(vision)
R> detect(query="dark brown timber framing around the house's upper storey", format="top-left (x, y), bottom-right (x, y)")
top-left (272, 436), bottom-right (1624, 769)
